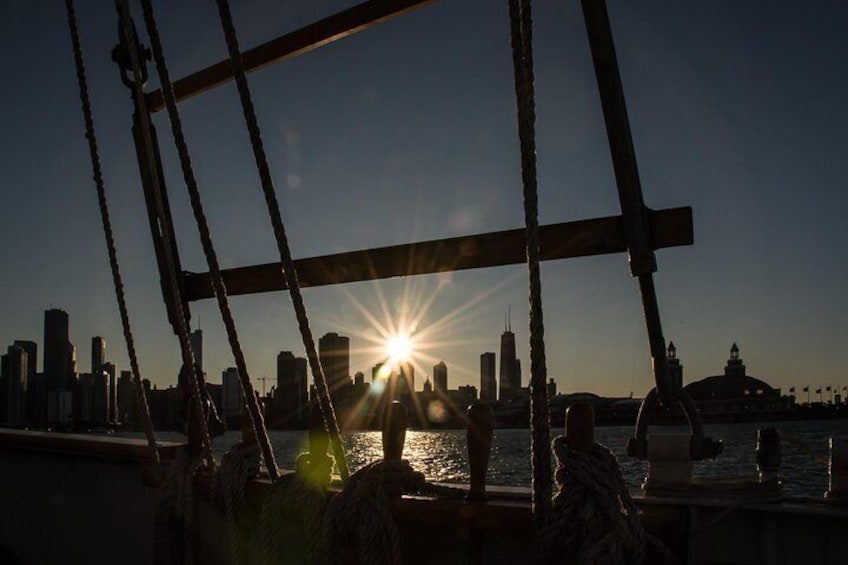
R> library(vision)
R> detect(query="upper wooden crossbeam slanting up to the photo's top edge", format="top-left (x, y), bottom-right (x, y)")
top-left (147, 0), bottom-right (435, 112)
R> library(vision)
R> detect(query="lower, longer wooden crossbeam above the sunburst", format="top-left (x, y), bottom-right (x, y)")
top-left (182, 207), bottom-right (693, 301)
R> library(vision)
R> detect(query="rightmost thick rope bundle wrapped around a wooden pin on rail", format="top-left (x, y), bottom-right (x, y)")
top-left (540, 437), bottom-right (645, 565)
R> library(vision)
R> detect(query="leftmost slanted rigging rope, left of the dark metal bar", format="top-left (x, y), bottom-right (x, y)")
top-left (65, 0), bottom-right (159, 465)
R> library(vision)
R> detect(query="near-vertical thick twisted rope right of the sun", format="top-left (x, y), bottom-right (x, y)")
top-left (509, 0), bottom-right (552, 533)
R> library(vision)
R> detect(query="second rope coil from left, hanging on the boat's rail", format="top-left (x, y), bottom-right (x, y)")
top-left (212, 443), bottom-right (260, 565)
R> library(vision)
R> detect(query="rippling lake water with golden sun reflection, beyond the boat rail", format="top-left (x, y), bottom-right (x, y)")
top-left (157, 420), bottom-right (848, 497)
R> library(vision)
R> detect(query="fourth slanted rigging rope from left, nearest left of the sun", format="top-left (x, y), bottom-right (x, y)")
top-left (214, 0), bottom-right (349, 481)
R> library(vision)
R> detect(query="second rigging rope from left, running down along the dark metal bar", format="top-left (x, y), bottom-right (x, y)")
top-left (115, 0), bottom-right (215, 469)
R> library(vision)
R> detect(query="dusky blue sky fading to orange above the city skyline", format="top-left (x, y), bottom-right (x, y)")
top-left (0, 0), bottom-right (848, 397)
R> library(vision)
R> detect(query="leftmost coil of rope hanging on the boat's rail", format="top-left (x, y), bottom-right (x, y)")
top-left (153, 448), bottom-right (203, 565)
